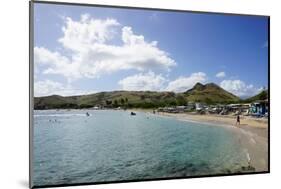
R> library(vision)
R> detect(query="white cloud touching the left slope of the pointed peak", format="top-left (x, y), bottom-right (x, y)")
top-left (165, 72), bottom-right (207, 92)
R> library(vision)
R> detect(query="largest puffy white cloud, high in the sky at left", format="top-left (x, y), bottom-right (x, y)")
top-left (34, 15), bottom-right (176, 80)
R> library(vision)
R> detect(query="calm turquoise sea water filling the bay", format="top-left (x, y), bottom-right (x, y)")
top-left (33, 110), bottom-right (248, 186)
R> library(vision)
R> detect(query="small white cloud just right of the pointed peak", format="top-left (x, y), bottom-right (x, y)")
top-left (220, 80), bottom-right (262, 98)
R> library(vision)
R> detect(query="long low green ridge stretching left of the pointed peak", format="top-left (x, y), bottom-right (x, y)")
top-left (34, 91), bottom-right (178, 109)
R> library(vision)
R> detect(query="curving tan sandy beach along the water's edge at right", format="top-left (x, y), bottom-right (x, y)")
top-left (130, 109), bottom-right (268, 172)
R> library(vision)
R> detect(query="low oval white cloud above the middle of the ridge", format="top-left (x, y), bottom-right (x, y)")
top-left (118, 71), bottom-right (166, 91)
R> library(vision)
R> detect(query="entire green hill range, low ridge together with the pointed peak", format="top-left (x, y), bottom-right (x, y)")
top-left (34, 83), bottom-right (240, 109)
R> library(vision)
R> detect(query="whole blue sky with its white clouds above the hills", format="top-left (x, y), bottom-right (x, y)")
top-left (34, 3), bottom-right (268, 97)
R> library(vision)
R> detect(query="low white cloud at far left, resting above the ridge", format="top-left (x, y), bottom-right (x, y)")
top-left (34, 80), bottom-right (95, 97)
